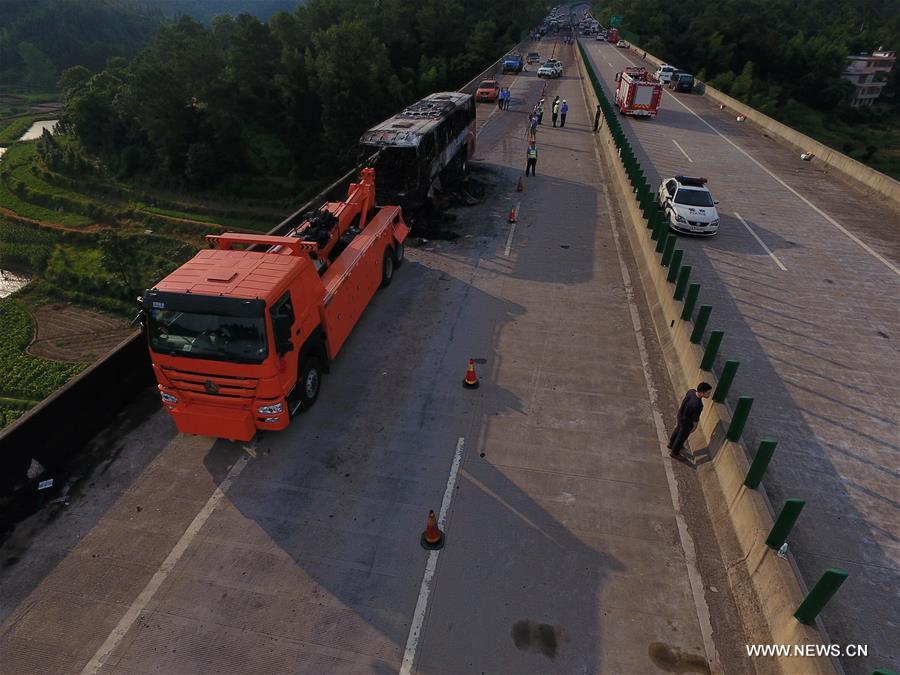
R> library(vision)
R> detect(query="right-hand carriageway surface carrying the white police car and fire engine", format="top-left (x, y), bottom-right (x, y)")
top-left (583, 38), bottom-right (900, 673)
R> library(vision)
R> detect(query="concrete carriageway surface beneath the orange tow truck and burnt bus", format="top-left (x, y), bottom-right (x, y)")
top-left (0, 44), bottom-right (748, 673)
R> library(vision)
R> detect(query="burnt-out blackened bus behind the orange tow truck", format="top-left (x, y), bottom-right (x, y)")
top-left (360, 91), bottom-right (475, 208)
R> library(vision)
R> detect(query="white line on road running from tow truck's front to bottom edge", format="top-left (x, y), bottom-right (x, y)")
top-left (81, 444), bottom-right (255, 675)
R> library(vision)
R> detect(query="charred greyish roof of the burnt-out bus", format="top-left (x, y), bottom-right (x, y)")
top-left (360, 91), bottom-right (472, 148)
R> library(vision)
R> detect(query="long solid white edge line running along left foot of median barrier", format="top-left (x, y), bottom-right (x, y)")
top-left (579, 61), bottom-right (724, 675)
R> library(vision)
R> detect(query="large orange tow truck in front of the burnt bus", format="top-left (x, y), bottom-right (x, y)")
top-left (141, 168), bottom-right (409, 441)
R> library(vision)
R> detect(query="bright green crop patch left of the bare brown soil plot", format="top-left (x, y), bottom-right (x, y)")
top-left (0, 298), bottom-right (84, 428)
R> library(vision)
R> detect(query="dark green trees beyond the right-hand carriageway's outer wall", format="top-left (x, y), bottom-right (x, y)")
top-left (594, 0), bottom-right (900, 178)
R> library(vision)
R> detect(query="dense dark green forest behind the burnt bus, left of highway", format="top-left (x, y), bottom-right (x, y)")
top-left (60, 0), bottom-right (546, 196)
